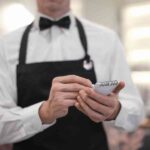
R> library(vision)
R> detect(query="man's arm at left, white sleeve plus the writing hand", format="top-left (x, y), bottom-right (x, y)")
top-left (0, 38), bottom-right (92, 144)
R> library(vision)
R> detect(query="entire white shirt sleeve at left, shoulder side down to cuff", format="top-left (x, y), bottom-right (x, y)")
top-left (0, 40), bottom-right (55, 144)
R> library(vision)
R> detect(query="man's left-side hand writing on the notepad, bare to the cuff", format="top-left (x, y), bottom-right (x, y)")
top-left (39, 75), bottom-right (92, 124)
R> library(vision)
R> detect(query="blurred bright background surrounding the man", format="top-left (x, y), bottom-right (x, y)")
top-left (0, 0), bottom-right (150, 150)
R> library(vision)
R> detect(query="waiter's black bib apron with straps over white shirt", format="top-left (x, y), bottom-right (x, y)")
top-left (13, 19), bottom-right (108, 150)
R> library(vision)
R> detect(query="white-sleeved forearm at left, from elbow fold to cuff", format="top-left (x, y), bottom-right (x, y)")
top-left (0, 103), bottom-right (55, 144)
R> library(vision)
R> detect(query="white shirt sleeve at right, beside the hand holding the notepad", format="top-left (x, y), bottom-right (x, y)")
top-left (110, 34), bottom-right (145, 131)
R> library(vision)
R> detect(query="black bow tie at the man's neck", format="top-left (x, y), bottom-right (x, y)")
top-left (39, 16), bottom-right (70, 30)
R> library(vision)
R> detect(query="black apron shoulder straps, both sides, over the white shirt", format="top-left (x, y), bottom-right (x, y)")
top-left (19, 18), bottom-right (90, 65)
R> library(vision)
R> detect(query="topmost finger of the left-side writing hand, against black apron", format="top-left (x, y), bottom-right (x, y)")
top-left (53, 75), bottom-right (92, 87)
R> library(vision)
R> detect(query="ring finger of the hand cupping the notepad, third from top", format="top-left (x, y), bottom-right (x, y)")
top-left (78, 95), bottom-right (104, 122)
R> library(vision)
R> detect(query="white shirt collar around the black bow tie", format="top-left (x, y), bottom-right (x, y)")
top-left (33, 11), bottom-right (76, 30)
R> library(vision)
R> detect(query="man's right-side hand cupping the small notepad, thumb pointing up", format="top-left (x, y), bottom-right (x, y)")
top-left (75, 82), bottom-right (125, 123)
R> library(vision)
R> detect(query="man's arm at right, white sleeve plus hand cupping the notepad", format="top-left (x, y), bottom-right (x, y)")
top-left (76, 32), bottom-right (144, 131)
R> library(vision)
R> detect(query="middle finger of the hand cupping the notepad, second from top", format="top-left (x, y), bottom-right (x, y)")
top-left (80, 91), bottom-right (112, 117)
